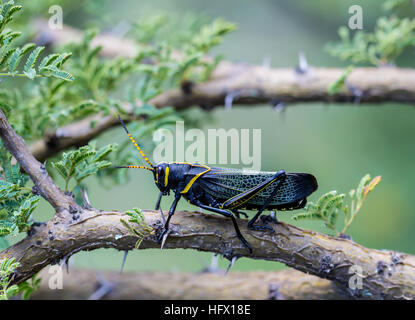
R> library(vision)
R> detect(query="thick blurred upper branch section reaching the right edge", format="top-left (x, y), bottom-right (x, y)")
top-left (152, 62), bottom-right (415, 110)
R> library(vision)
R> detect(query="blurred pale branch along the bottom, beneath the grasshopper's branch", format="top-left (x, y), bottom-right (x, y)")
top-left (31, 268), bottom-right (350, 300)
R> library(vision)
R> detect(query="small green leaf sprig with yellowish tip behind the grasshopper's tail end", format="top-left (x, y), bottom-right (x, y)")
top-left (293, 174), bottom-right (381, 236)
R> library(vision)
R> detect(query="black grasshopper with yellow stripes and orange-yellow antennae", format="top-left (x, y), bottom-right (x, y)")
top-left (116, 116), bottom-right (318, 253)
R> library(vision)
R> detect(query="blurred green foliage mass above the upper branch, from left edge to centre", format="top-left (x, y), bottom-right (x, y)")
top-left (0, 5), bottom-right (234, 142)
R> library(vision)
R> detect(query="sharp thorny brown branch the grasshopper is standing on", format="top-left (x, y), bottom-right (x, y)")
top-left (0, 209), bottom-right (415, 299)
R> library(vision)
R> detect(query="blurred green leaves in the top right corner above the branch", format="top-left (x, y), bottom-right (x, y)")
top-left (327, 0), bottom-right (415, 66)
